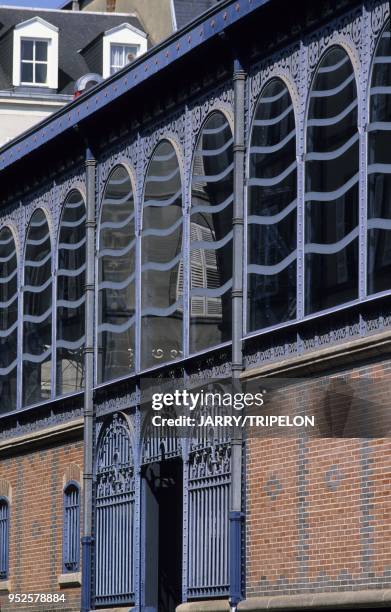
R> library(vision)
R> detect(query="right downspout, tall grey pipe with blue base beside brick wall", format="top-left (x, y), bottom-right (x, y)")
top-left (229, 52), bottom-right (246, 610)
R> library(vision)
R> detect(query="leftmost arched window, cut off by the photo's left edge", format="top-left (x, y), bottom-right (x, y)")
top-left (0, 227), bottom-right (18, 412)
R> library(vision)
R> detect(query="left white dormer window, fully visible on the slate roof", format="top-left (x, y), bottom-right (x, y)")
top-left (12, 17), bottom-right (58, 89)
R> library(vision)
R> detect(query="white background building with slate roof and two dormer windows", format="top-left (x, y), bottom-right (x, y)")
top-left (0, 7), bottom-right (148, 145)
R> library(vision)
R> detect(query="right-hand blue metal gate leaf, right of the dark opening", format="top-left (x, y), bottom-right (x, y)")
top-left (188, 441), bottom-right (231, 598)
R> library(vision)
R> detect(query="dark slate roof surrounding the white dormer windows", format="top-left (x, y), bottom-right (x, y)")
top-left (0, 6), bottom-right (144, 95)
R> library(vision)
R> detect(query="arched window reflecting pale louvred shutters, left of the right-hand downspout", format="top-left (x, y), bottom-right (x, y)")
top-left (190, 112), bottom-right (233, 353)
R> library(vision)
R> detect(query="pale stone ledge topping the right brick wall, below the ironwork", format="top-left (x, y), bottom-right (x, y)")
top-left (240, 330), bottom-right (391, 380)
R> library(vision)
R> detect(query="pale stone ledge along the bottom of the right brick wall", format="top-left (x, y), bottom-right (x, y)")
top-left (238, 589), bottom-right (391, 612)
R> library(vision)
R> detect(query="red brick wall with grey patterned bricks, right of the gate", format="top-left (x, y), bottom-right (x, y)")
top-left (246, 362), bottom-right (391, 597)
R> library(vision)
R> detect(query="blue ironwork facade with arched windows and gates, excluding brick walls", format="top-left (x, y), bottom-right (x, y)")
top-left (0, 0), bottom-right (391, 607)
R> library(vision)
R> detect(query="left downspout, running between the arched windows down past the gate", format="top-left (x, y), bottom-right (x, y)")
top-left (81, 147), bottom-right (96, 612)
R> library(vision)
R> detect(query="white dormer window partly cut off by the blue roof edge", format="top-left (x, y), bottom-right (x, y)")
top-left (102, 23), bottom-right (148, 78)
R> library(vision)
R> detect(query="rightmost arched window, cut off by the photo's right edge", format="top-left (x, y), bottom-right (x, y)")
top-left (367, 24), bottom-right (391, 294)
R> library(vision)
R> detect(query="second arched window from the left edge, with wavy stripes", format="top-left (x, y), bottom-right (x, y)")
top-left (23, 209), bottom-right (52, 405)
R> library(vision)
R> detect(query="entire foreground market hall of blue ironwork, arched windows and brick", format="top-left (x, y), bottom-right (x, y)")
top-left (0, 0), bottom-right (391, 612)
